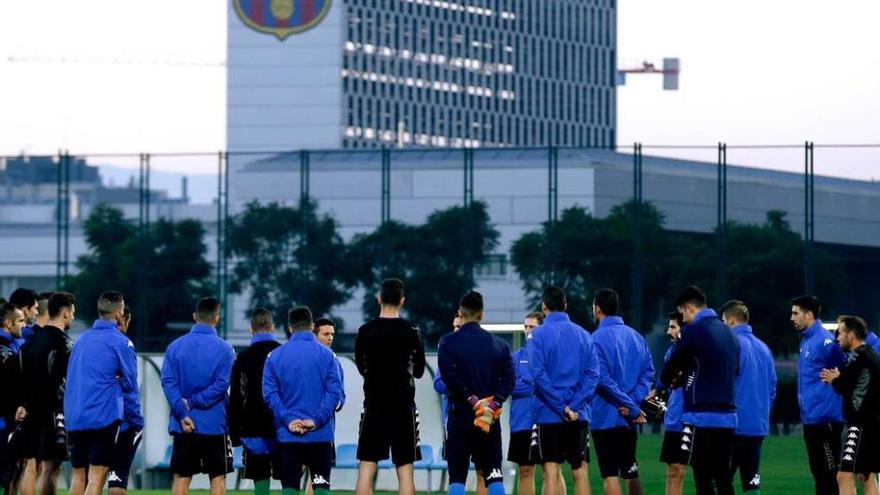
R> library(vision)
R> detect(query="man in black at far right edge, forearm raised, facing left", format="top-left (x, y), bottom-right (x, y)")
top-left (820, 316), bottom-right (880, 495)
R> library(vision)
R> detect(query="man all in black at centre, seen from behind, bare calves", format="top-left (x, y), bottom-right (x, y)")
top-left (354, 279), bottom-right (425, 495)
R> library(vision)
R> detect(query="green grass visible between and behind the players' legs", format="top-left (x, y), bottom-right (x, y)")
top-left (67, 434), bottom-right (813, 495)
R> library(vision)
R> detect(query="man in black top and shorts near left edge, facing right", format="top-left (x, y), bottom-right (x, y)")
top-left (21, 292), bottom-right (76, 495)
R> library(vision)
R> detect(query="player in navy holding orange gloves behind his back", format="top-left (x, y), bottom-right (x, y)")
top-left (437, 291), bottom-right (516, 495)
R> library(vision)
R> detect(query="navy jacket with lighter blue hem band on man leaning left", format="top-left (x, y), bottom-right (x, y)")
top-left (661, 308), bottom-right (739, 429)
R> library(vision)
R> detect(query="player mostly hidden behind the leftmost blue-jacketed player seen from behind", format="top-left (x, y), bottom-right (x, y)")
top-left (107, 304), bottom-right (144, 495)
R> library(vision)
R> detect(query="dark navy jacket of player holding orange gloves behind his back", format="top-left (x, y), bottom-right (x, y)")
top-left (437, 322), bottom-right (516, 427)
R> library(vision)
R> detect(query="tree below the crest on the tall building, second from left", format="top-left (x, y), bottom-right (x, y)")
top-left (227, 201), bottom-right (355, 326)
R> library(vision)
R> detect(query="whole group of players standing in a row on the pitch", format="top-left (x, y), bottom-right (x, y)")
top-left (0, 279), bottom-right (880, 495)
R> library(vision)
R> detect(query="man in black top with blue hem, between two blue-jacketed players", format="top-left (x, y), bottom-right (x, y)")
top-left (229, 308), bottom-right (281, 495)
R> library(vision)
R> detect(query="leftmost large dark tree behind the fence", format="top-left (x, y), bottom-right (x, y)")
top-left (67, 204), bottom-right (213, 350)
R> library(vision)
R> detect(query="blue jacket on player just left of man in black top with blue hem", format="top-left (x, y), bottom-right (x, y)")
top-left (162, 323), bottom-right (235, 435)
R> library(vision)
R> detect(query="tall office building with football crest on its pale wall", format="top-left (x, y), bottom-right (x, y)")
top-left (227, 0), bottom-right (616, 151)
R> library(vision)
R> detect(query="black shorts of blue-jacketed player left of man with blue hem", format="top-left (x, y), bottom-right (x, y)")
top-left (171, 433), bottom-right (232, 478)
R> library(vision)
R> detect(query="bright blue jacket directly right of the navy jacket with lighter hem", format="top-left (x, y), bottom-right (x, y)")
top-left (733, 325), bottom-right (776, 437)
